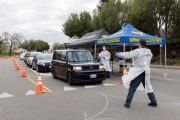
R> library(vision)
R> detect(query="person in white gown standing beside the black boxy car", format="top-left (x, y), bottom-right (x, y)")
top-left (99, 46), bottom-right (112, 78)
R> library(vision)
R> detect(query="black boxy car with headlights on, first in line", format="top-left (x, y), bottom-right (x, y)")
top-left (51, 50), bottom-right (106, 85)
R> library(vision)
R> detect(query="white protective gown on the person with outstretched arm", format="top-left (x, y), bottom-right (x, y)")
top-left (120, 48), bottom-right (153, 93)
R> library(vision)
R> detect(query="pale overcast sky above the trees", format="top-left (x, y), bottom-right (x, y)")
top-left (0, 0), bottom-right (99, 46)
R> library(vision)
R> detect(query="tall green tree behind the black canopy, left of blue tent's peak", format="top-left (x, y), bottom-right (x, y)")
top-left (91, 0), bottom-right (123, 34)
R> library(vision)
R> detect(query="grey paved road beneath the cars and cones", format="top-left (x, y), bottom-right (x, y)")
top-left (0, 60), bottom-right (180, 120)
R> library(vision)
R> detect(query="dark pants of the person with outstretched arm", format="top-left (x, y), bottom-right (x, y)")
top-left (126, 72), bottom-right (157, 105)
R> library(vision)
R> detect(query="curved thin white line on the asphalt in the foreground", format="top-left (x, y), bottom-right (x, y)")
top-left (84, 93), bottom-right (111, 120)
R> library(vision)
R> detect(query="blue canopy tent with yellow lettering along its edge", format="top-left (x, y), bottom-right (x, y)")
top-left (94, 24), bottom-right (167, 75)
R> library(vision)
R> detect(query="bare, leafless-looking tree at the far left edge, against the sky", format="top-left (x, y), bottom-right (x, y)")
top-left (1, 32), bottom-right (24, 56)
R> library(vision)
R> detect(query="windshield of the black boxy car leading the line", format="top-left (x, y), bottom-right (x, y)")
top-left (67, 51), bottom-right (93, 62)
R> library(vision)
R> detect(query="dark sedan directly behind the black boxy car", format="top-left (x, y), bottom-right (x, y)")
top-left (32, 53), bottom-right (53, 72)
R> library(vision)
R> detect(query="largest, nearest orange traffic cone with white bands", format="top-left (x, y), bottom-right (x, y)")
top-left (35, 73), bottom-right (45, 94)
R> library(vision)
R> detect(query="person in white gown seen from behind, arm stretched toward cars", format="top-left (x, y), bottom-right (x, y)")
top-left (115, 39), bottom-right (157, 108)
